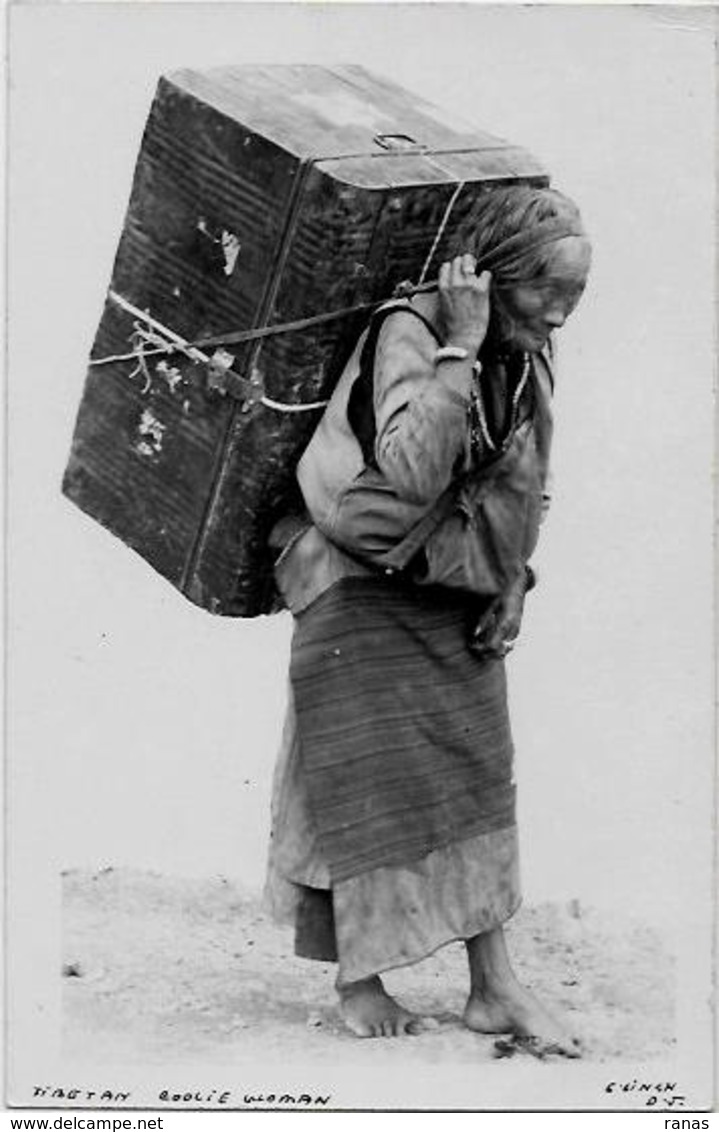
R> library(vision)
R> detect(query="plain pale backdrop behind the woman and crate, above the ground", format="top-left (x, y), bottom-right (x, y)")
top-left (8, 5), bottom-right (713, 927)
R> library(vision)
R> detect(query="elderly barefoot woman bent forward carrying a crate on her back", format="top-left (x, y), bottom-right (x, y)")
top-left (264, 186), bottom-right (590, 1056)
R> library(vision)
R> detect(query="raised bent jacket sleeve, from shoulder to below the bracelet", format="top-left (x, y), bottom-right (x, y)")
top-left (375, 311), bottom-right (472, 503)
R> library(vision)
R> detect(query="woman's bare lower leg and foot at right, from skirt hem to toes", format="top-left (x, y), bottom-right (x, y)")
top-left (464, 927), bottom-right (581, 1057)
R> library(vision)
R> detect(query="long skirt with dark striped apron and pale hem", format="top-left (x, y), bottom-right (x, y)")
top-left (261, 577), bottom-right (520, 983)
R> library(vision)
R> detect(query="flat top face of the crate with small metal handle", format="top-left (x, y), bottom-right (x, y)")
top-left (164, 63), bottom-right (545, 188)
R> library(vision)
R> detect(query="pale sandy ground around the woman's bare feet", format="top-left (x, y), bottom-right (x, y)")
top-left (62, 868), bottom-right (674, 1067)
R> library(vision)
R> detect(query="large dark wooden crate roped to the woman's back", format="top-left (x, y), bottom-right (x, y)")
top-left (63, 66), bottom-right (547, 616)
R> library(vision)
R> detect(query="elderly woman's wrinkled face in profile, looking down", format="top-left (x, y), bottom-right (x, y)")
top-left (495, 235), bottom-right (591, 353)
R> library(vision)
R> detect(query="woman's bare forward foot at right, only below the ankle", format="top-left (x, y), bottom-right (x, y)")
top-left (464, 984), bottom-right (581, 1057)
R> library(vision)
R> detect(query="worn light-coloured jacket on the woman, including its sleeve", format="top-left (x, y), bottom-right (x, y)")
top-left (276, 307), bottom-right (553, 612)
